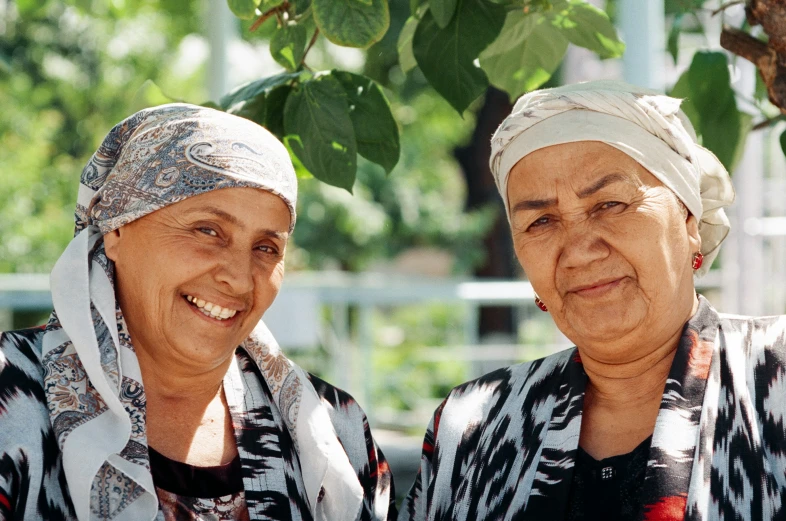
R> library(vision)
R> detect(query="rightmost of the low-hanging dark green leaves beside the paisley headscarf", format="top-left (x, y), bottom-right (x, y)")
top-left (331, 70), bottom-right (401, 174)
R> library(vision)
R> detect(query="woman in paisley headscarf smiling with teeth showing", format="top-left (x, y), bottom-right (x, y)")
top-left (0, 104), bottom-right (395, 521)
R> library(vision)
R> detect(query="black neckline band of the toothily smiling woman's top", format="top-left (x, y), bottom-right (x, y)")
top-left (148, 447), bottom-right (243, 498)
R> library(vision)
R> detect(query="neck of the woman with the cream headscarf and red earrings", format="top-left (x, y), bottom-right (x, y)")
top-left (579, 297), bottom-right (698, 410)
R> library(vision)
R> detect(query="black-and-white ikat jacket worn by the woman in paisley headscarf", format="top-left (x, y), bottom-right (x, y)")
top-left (0, 328), bottom-right (396, 521)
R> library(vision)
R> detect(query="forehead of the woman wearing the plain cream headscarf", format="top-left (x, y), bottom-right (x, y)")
top-left (508, 141), bottom-right (663, 195)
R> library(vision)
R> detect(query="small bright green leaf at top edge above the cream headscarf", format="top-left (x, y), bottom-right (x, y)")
top-left (545, 0), bottom-right (625, 58)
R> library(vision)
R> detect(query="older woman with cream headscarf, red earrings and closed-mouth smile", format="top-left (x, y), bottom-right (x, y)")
top-left (399, 82), bottom-right (786, 521)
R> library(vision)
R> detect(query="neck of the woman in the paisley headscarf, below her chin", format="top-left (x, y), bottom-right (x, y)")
top-left (137, 348), bottom-right (234, 404)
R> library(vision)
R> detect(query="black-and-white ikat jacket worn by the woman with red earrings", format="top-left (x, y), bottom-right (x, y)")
top-left (399, 297), bottom-right (786, 521)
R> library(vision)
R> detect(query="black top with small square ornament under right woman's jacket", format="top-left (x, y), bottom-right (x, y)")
top-left (566, 436), bottom-right (652, 521)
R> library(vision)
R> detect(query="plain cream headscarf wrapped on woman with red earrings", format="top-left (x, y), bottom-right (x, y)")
top-left (490, 80), bottom-right (734, 276)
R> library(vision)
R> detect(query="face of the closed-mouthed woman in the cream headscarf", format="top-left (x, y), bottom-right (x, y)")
top-left (507, 141), bottom-right (701, 363)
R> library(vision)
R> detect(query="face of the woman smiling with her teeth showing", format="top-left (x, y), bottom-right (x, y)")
top-left (104, 188), bottom-right (290, 368)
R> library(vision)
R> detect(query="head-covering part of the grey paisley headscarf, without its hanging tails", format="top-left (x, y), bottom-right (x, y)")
top-left (75, 103), bottom-right (297, 235)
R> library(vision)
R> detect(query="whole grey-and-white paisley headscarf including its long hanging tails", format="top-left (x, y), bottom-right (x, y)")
top-left (42, 104), bottom-right (363, 521)
